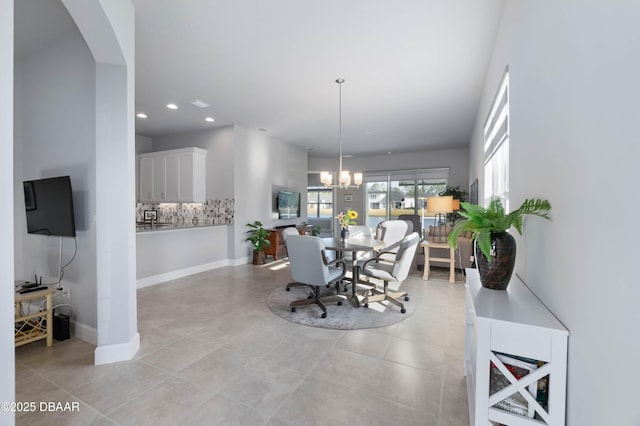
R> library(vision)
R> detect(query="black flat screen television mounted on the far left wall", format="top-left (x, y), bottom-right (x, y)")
top-left (23, 176), bottom-right (76, 237)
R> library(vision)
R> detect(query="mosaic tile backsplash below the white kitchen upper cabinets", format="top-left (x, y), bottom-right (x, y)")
top-left (136, 198), bottom-right (234, 225)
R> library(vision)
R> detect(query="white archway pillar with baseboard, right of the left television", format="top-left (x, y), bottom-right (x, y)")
top-left (62, 0), bottom-right (140, 364)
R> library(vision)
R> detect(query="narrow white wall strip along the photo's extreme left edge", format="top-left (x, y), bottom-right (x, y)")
top-left (0, 0), bottom-right (16, 426)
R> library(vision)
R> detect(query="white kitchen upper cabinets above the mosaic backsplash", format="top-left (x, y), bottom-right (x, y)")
top-left (138, 147), bottom-right (207, 203)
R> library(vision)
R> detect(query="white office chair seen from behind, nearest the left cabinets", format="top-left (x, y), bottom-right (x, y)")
top-left (287, 235), bottom-right (346, 318)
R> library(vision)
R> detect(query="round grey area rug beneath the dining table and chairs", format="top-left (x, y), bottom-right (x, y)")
top-left (267, 286), bottom-right (416, 330)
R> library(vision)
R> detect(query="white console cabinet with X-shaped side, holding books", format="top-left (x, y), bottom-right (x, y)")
top-left (465, 269), bottom-right (569, 426)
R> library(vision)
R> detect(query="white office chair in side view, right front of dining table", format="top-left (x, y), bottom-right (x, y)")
top-left (362, 232), bottom-right (420, 314)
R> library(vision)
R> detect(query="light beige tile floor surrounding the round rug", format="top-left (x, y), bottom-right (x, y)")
top-left (16, 262), bottom-right (469, 426)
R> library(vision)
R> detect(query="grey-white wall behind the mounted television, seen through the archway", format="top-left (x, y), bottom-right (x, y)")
top-left (14, 32), bottom-right (97, 330)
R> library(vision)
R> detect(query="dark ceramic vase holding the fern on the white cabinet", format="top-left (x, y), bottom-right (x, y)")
top-left (475, 232), bottom-right (516, 290)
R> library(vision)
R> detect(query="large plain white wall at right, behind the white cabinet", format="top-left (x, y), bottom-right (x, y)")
top-left (470, 0), bottom-right (640, 426)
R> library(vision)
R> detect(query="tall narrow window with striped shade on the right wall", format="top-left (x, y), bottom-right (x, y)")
top-left (484, 68), bottom-right (509, 211)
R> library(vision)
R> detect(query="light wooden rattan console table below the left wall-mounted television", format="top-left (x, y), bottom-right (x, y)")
top-left (14, 288), bottom-right (54, 347)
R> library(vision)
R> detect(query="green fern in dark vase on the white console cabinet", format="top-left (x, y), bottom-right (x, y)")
top-left (448, 198), bottom-right (551, 290)
